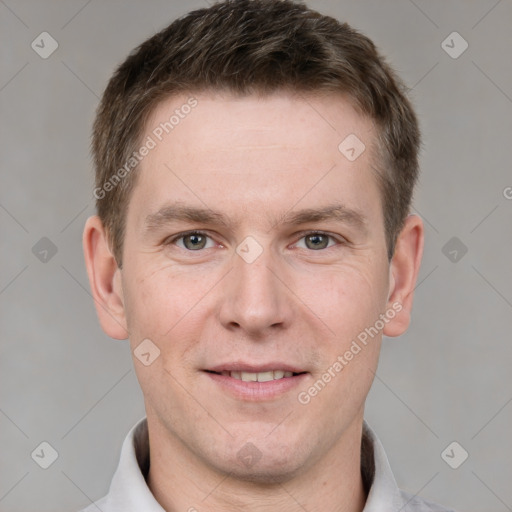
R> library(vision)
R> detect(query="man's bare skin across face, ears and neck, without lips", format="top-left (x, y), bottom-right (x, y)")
top-left (84, 92), bottom-right (423, 512)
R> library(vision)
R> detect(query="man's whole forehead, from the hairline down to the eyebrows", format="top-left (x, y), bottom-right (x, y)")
top-left (134, 92), bottom-right (379, 226)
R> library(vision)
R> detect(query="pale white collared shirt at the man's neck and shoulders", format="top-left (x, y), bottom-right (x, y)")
top-left (82, 418), bottom-right (453, 512)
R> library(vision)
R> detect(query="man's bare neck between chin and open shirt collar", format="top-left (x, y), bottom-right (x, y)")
top-left (147, 416), bottom-right (366, 512)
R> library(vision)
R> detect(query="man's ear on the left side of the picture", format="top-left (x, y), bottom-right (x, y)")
top-left (83, 215), bottom-right (128, 340)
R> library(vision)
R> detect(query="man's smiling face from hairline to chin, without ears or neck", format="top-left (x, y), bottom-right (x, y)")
top-left (121, 93), bottom-right (392, 481)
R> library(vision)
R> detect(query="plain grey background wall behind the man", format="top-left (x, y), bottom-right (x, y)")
top-left (0, 0), bottom-right (512, 512)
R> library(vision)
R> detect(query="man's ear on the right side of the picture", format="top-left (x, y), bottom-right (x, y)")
top-left (383, 215), bottom-right (424, 336)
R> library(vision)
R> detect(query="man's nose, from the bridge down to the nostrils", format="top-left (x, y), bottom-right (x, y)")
top-left (220, 240), bottom-right (293, 337)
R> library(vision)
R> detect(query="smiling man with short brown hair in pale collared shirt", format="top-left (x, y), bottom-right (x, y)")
top-left (84, 0), bottom-right (454, 512)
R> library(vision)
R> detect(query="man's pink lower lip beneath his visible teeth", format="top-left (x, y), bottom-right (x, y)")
top-left (204, 371), bottom-right (308, 402)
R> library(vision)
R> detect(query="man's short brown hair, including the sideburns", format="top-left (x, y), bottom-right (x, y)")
top-left (92, 0), bottom-right (420, 266)
